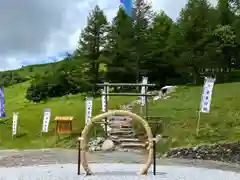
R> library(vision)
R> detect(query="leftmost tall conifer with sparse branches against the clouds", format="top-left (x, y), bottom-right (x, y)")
top-left (77, 6), bottom-right (108, 92)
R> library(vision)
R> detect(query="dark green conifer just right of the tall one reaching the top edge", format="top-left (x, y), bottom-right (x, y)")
top-left (143, 12), bottom-right (175, 84)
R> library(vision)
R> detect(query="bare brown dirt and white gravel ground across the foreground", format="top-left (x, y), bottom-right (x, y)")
top-left (0, 149), bottom-right (240, 180)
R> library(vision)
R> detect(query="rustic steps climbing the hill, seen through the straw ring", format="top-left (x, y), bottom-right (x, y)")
top-left (108, 116), bottom-right (146, 150)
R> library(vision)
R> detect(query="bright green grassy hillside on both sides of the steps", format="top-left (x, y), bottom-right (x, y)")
top-left (0, 82), bottom-right (240, 148)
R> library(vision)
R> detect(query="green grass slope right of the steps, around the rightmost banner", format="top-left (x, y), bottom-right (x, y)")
top-left (150, 83), bottom-right (240, 152)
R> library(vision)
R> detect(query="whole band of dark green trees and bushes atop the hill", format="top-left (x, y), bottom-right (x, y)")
top-left (27, 0), bottom-right (240, 102)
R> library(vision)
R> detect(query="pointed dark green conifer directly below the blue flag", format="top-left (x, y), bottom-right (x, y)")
top-left (105, 8), bottom-right (135, 82)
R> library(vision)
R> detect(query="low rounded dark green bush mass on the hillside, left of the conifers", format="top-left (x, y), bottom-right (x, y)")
top-left (26, 61), bottom-right (91, 102)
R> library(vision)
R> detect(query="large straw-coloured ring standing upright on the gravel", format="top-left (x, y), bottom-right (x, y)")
top-left (80, 110), bottom-right (153, 175)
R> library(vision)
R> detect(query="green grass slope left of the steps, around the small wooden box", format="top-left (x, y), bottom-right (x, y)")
top-left (0, 82), bottom-right (135, 148)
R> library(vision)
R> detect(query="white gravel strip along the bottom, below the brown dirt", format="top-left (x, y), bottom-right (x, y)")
top-left (0, 163), bottom-right (240, 180)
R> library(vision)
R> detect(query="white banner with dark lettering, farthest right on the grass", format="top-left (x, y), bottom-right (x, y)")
top-left (200, 77), bottom-right (215, 113)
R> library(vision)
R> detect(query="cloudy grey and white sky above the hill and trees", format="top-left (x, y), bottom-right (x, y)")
top-left (0, 0), bottom-right (216, 70)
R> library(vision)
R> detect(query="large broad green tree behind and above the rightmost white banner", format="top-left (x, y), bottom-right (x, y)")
top-left (175, 0), bottom-right (217, 83)
